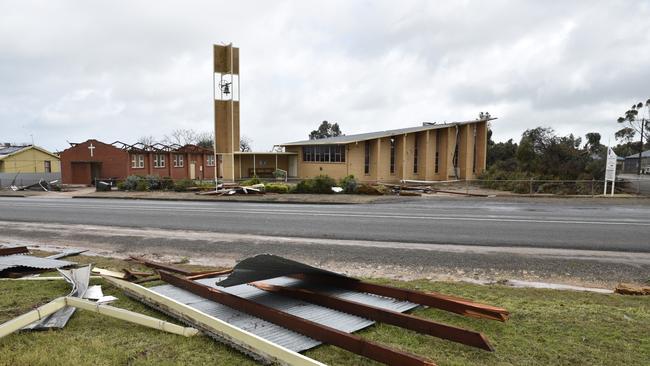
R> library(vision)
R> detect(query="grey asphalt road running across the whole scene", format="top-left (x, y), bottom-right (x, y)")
top-left (0, 197), bottom-right (650, 252)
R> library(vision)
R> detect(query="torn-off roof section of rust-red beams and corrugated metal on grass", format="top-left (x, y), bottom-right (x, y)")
top-left (121, 254), bottom-right (509, 365)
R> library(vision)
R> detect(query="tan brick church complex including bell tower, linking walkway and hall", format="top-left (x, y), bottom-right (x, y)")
top-left (212, 45), bottom-right (492, 182)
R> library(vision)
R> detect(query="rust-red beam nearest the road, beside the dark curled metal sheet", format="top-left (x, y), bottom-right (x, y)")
top-left (291, 274), bottom-right (510, 322)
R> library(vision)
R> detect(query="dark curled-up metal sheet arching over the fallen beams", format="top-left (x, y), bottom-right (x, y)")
top-left (219, 254), bottom-right (350, 287)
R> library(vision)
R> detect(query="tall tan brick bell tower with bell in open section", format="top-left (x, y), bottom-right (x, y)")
top-left (212, 43), bottom-right (239, 182)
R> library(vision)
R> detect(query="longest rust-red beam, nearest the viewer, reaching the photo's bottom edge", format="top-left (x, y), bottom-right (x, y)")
top-left (160, 271), bottom-right (435, 366)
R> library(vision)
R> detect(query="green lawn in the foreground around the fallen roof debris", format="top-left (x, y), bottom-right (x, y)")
top-left (0, 256), bottom-right (650, 366)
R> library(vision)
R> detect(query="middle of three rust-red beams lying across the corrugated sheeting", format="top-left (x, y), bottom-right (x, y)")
top-left (251, 282), bottom-right (494, 351)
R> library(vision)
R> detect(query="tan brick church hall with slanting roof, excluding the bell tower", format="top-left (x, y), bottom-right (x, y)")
top-left (280, 120), bottom-right (487, 182)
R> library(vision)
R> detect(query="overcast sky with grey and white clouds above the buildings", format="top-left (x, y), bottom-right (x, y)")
top-left (0, 0), bottom-right (650, 151)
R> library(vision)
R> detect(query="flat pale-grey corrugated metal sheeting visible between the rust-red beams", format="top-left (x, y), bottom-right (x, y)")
top-left (151, 277), bottom-right (417, 352)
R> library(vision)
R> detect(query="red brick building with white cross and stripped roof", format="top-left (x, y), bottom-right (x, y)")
top-left (61, 140), bottom-right (215, 184)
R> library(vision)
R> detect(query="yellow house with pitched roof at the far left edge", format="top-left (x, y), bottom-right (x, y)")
top-left (0, 144), bottom-right (61, 173)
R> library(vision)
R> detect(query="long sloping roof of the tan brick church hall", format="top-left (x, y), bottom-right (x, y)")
top-left (279, 118), bottom-right (496, 146)
